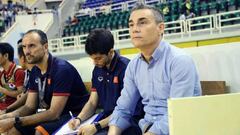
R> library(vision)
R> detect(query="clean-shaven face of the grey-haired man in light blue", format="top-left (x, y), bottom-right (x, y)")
top-left (129, 9), bottom-right (164, 49)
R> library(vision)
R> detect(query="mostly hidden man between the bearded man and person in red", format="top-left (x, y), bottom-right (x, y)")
top-left (0, 39), bottom-right (34, 116)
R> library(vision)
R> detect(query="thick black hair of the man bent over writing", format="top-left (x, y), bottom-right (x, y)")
top-left (85, 28), bottom-right (114, 55)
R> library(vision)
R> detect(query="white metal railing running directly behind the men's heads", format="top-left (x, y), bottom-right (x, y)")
top-left (49, 10), bottom-right (240, 53)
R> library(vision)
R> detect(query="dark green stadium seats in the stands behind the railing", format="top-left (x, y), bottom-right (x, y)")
top-left (63, 0), bottom-right (240, 37)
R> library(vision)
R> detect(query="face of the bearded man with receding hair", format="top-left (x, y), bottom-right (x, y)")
top-left (22, 32), bottom-right (48, 64)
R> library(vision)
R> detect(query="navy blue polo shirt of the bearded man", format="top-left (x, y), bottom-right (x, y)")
top-left (29, 54), bottom-right (89, 114)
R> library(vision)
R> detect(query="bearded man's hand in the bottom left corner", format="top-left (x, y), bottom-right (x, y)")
top-left (0, 118), bottom-right (14, 133)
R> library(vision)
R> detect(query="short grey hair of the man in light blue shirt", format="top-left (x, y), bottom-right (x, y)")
top-left (131, 2), bottom-right (164, 23)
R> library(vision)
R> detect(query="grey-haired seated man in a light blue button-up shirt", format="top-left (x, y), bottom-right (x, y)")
top-left (109, 4), bottom-right (201, 135)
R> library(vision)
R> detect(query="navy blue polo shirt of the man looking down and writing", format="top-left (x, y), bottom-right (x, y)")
top-left (91, 52), bottom-right (129, 115)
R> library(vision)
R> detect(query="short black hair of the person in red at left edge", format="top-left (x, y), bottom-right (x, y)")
top-left (0, 42), bottom-right (14, 61)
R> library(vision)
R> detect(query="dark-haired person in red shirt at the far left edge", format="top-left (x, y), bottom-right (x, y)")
top-left (0, 43), bottom-right (24, 110)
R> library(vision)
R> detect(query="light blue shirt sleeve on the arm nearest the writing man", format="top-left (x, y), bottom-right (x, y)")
top-left (109, 63), bottom-right (140, 130)
